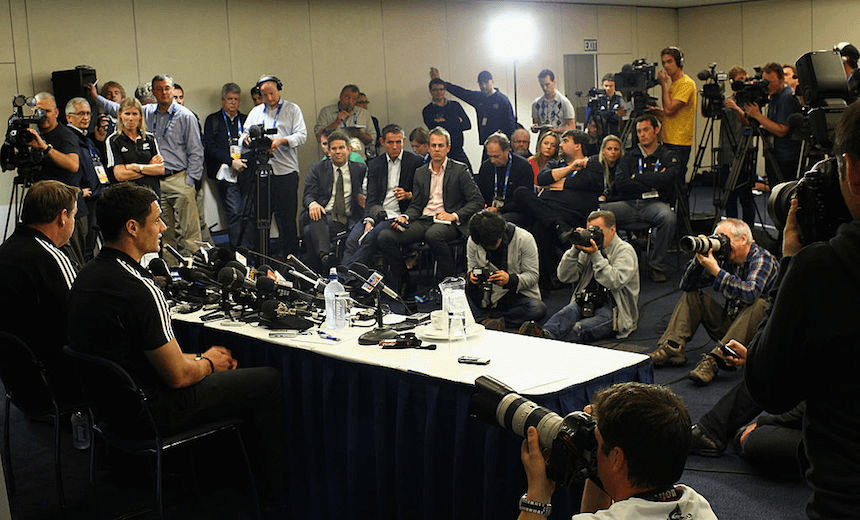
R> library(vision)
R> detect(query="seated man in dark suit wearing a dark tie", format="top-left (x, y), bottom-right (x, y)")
top-left (299, 132), bottom-right (367, 274)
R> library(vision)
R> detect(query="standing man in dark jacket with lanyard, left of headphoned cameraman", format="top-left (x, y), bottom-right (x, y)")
top-left (203, 83), bottom-right (250, 251)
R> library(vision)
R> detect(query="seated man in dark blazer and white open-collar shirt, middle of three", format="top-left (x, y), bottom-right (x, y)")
top-left (343, 124), bottom-right (424, 266)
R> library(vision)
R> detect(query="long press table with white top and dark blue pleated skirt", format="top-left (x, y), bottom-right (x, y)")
top-left (174, 314), bottom-right (653, 520)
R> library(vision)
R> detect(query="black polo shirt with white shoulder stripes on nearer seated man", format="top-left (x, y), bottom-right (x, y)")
top-left (69, 247), bottom-right (174, 395)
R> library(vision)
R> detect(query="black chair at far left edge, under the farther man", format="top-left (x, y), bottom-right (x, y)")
top-left (0, 331), bottom-right (86, 513)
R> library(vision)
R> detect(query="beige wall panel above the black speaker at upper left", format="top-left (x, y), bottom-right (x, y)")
top-left (23, 0), bottom-right (138, 94)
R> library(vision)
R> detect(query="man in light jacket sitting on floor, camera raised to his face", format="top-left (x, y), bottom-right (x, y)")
top-left (519, 210), bottom-right (639, 343)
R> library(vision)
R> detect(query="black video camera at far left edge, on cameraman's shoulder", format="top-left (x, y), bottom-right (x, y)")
top-left (0, 94), bottom-right (48, 176)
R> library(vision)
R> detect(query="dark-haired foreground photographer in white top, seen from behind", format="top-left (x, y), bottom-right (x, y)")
top-left (519, 383), bottom-right (716, 520)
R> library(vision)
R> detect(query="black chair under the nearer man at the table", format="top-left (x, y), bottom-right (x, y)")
top-left (63, 345), bottom-right (260, 518)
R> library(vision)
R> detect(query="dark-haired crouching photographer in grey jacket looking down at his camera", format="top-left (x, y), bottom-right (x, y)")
top-left (466, 209), bottom-right (546, 330)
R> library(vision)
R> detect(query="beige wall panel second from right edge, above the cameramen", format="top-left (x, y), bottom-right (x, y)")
top-left (741, 0), bottom-right (812, 69)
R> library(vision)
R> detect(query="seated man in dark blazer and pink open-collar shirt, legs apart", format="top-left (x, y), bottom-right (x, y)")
top-left (377, 127), bottom-right (484, 294)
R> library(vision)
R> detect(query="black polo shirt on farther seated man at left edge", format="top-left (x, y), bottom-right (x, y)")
top-left (0, 224), bottom-right (77, 408)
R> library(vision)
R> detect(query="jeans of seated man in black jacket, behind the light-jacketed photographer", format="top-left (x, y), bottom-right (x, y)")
top-left (600, 200), bottom-right (678, 272)
